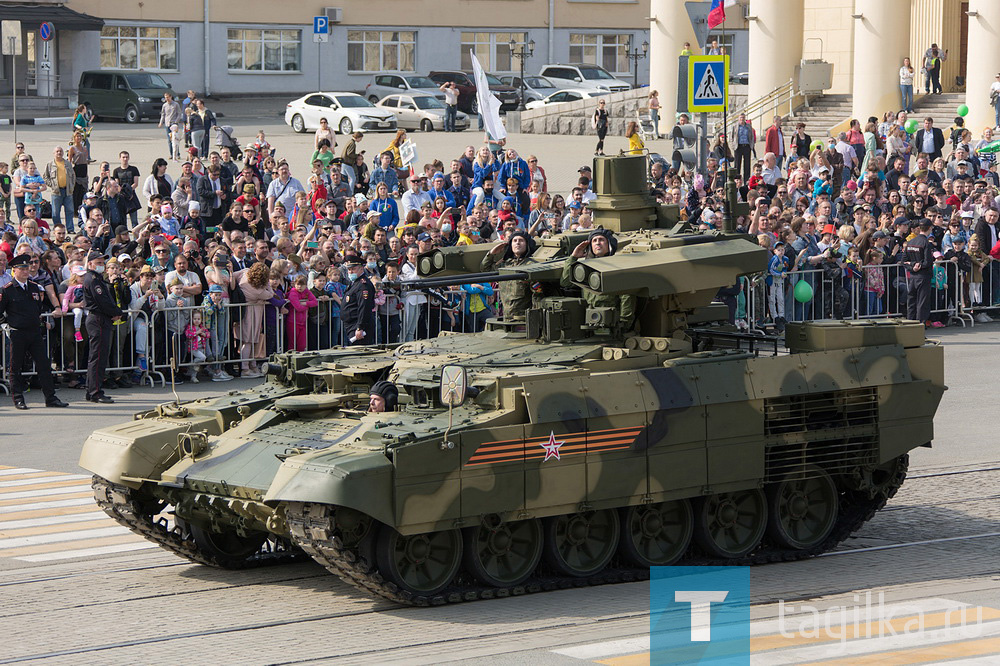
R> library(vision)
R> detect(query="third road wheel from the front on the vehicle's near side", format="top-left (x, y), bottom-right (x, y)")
top-left (544, 510), bottom-right (620, 578)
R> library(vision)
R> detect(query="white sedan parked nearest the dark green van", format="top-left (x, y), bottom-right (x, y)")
top-left (285, 92), bottom-right (396, 134)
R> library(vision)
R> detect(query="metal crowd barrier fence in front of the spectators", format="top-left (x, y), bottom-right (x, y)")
top-left (0, 261), bottom-right (990, 393)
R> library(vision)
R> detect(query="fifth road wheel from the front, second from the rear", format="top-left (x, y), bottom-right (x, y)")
top-left (694, 488), bottom-right (767, 560)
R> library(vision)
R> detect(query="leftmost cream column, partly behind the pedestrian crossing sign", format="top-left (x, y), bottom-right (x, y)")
top-left (649, 0), bottom-right (701, 134)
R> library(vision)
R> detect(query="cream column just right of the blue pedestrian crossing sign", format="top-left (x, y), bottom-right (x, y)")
top-left (747, 0), bottom-right (805, 107)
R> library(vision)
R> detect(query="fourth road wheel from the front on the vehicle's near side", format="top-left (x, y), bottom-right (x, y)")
top-left (618, 500), bottom-right (694, 567)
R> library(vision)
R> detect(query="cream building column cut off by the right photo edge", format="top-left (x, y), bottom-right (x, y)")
top-left (956, 0), bottom-right (1000, 132)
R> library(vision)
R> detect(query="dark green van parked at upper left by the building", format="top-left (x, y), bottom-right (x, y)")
top-left (78, 69), bottom-right (179, 123)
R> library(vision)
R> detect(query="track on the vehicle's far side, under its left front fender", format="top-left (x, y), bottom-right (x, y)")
top-left (91, 476), bottom-right (306, 569)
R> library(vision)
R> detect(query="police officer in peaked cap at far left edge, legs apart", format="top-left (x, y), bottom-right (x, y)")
top-left (0, 254), bottom-right (69, 409)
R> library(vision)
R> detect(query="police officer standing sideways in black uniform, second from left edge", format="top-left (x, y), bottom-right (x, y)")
top-left (83, 252), bottom-right (124, 403)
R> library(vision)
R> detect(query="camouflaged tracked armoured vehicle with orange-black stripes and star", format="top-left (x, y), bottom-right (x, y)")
top-left (81, 156), bottom-right (945, 605)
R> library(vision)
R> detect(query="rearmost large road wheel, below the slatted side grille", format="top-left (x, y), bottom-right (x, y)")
top-left (766, 467), bottom-right (840, 550)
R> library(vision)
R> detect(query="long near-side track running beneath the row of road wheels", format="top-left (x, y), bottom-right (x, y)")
top-left (285, 456), bottom-right (908, 606)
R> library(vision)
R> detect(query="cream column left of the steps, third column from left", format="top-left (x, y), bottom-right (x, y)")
top-left (851, 0), bottom-right (920, 122)
